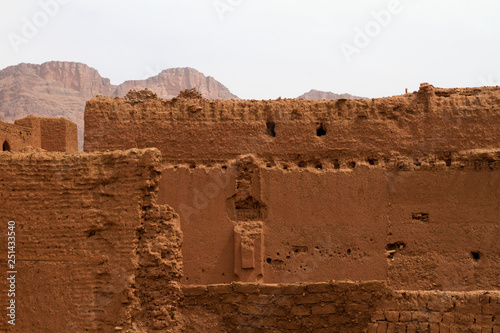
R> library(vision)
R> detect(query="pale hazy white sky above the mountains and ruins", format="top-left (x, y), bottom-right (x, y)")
top-left (0, 0), bottom-right (500, 99)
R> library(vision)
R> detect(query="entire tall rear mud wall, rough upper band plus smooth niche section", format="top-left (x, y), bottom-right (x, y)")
top-left (85, 85), bottom-right (500, 290)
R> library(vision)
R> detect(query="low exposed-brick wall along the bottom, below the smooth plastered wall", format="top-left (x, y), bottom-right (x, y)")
top-left (181, 282), bottom-right (500, 333)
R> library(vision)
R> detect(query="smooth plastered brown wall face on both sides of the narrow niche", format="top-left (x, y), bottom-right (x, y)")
top-left (159, 151), bottom-right (500, 290)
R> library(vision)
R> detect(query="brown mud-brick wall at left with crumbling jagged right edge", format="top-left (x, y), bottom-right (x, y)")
top-left (0, 149), bottom-right (182, 333)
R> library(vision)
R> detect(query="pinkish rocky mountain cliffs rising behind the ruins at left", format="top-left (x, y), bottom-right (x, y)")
top-left (0, 61), bottom-right (238, 148)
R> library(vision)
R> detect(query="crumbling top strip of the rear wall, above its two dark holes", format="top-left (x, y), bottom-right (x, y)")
top-left (86, 83), bottom-right (500, 122)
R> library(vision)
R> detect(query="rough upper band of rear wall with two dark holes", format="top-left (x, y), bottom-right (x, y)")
top-left (84, 86), bottom-right (500, 159)
